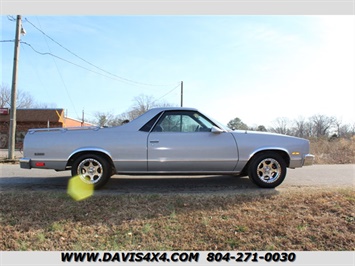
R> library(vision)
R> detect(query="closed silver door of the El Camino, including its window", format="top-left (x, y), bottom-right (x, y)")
top-left (147, 111), bottom-right (238, 173)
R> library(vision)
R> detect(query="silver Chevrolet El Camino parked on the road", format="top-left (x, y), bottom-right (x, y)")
top-left (20, 107), bottom-right (314, 188)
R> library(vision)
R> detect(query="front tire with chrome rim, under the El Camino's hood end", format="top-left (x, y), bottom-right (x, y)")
top-left (248, 152), bottom-right (286, 188)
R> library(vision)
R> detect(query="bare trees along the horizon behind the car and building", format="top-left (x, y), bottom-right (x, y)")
top-left (0, 85), bottom-right (355, 138)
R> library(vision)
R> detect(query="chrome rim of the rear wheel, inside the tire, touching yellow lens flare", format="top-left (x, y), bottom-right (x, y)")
top-left (77, 158), bottom-right (104, 184)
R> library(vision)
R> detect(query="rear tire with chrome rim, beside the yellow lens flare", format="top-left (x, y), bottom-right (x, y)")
top-left (71, 154), bottom-right (112, 189)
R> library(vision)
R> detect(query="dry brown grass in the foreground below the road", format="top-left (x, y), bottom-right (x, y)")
top-left (0, 188), bottom-right (355, 250)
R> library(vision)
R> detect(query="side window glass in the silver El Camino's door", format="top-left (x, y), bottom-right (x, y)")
top-left (153, 111), bottom-right (213, 133)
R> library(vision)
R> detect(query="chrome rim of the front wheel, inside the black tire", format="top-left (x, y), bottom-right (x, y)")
top-left (256, 158), bottom-right (282, 183)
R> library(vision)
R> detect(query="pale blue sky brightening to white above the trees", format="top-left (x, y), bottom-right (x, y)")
top-left (0, 15), bottom-right (355, 127)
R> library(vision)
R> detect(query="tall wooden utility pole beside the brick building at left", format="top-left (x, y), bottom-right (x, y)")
top-left (8, 15), bottom-right (22, 160)
